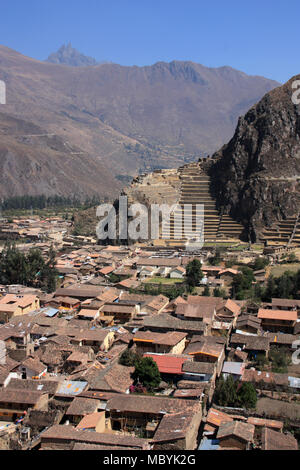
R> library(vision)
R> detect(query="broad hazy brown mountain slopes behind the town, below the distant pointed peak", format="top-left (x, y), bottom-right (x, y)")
top-left (0, 46), bottom-right (278, 197)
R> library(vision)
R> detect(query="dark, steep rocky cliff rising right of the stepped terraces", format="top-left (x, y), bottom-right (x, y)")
top-left (210, 76), bottom-right (300, 240)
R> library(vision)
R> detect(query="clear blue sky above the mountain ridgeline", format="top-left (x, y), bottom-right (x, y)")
top-left (0, 0), bottom-right (300, 82)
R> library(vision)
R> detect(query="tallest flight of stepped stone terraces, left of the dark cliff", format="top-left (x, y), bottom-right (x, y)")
top-left (160, 162), bottom-right (243, 246)
